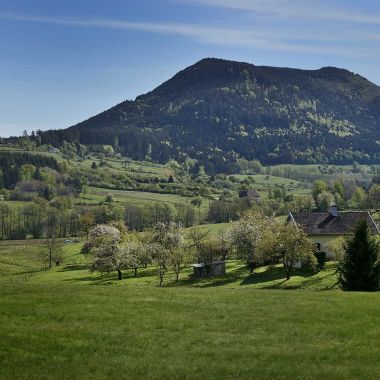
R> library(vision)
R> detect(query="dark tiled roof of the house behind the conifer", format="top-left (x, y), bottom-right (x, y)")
top-left (288, 211), bottom-right (380, 235)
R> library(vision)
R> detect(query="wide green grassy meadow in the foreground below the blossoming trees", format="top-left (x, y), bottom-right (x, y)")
top-left (0, 242), bottom-right (380, 379)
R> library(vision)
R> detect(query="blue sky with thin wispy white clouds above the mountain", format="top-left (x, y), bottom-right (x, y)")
top-left (0, 0), bottom-right (380, 136)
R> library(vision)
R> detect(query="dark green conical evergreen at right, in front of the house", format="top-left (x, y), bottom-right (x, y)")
top-left (338, 220), bottom-right (380, 291)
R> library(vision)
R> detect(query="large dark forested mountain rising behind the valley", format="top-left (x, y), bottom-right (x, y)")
top-left (43, 58), bottom-right (380, 172)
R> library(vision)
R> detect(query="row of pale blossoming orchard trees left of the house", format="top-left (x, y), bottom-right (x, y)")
top-left (83, 212), bottom-right (316, 285)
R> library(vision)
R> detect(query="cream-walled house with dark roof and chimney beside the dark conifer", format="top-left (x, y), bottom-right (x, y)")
top-left (288, 206), bottom-right (380, 259)
